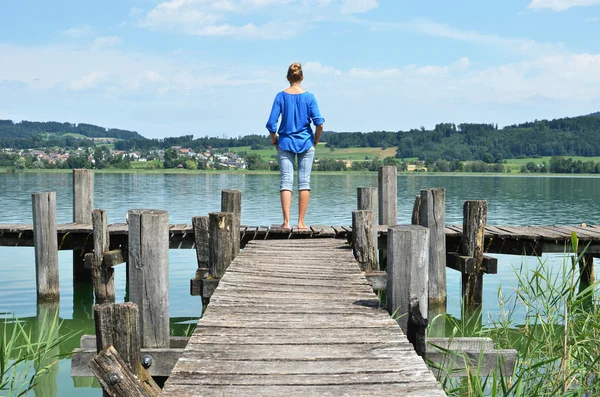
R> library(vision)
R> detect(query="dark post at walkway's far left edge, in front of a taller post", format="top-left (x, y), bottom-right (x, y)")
top-left (208, 212), bottom-right (233, 279)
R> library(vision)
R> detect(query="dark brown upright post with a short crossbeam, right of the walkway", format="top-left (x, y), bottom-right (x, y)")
top-left (461, 200), bottom-right (488, 313)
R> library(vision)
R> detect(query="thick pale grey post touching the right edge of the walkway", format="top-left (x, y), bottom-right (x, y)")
top-left (386, 225), bottom-right (429, 356)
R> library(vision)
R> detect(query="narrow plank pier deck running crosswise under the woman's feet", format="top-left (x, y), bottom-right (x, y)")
top-left (0, 223), bottom-right (600, 256)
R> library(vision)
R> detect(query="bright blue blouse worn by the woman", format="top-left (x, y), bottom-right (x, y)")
top-left (266, 91), bottom-right (325, 153)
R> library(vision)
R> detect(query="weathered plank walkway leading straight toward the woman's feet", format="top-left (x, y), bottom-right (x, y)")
top-left (161, 238), bottom-right (445, 397)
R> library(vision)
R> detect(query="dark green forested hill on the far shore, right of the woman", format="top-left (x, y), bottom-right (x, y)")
top-left (323, 113), bottom-right (600, 163)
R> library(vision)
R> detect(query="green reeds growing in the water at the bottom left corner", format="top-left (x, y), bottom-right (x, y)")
top-left (0, 314), bottom-right (70, 397)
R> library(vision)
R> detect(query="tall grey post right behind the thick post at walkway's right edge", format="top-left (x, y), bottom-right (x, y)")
top-left (418, 188), bottom-right (447, 336)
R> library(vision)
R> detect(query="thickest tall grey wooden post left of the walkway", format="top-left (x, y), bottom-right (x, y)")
top-left (128, 210), bottom-right (170, 348)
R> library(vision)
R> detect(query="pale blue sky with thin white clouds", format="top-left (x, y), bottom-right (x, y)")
top-left (0, 0), bottom-right (600, 138)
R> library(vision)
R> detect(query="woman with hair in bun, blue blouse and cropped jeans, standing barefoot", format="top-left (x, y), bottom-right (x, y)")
top-left (267, 63), bottom-right (325, 229)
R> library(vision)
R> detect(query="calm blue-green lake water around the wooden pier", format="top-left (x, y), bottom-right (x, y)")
top-left (0, 173), bottom-right (600, 397)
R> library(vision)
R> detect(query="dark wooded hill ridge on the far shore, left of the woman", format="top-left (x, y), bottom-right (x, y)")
top-left (0, 120), bottom-right (146, 140)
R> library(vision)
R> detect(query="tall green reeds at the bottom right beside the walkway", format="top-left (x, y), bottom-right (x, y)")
top-left (439, 236), bottom-right (600, 397)
